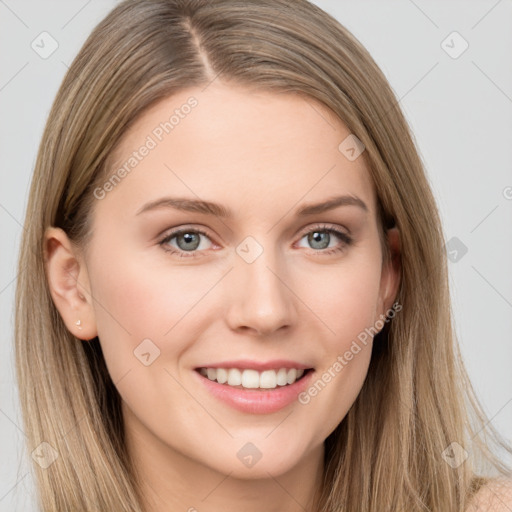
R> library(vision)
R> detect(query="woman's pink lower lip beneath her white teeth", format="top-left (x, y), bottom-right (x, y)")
top-left (194, 370), bottom-right (313, 414)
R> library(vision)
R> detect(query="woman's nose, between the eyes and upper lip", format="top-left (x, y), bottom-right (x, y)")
top-left (227, 250), bottom-right (297, 336)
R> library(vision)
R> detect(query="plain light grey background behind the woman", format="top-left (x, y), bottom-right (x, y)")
top-left (0, 0), bottom-right (512, 511)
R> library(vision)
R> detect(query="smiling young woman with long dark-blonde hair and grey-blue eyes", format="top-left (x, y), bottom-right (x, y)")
top-left (16, 0), bottom-right (512, 512)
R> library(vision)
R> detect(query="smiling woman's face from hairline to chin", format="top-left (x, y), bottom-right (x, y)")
top-left (49, 81), bottom-right (398, 478)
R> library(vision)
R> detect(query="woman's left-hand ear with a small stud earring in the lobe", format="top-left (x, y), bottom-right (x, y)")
top-left (44, 227), bottom-right (98, 340)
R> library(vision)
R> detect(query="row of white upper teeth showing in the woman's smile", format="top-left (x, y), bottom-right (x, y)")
top-left (199, 368), bottom-right (304, 389)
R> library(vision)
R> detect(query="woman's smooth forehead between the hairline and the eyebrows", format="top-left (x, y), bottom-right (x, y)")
top-left (97, 82), bottom-right (375, 220)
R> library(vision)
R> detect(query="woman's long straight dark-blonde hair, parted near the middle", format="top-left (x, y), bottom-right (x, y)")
top-left (15, 0), bottom-right (512, 512)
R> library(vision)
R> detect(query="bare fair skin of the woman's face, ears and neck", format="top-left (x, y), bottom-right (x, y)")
top-left (46, 80), bottom-right (399, 512)
